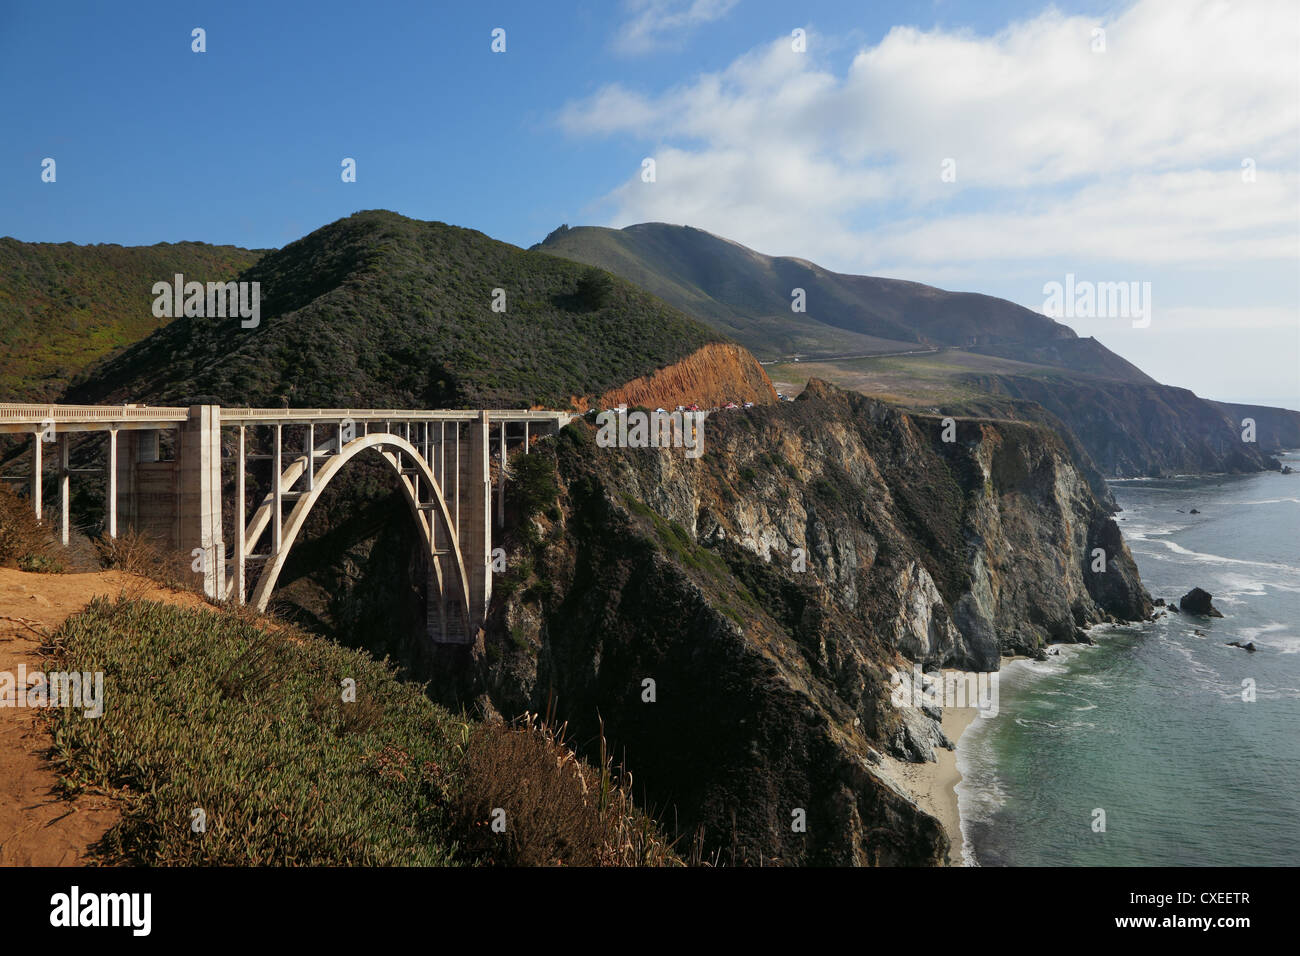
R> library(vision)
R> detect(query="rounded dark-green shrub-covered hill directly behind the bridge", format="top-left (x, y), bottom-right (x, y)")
top-left (68, 211), bottom-right (733, 407)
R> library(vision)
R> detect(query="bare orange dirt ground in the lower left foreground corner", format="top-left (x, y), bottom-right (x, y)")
top-left (0, 568), bottom-right (203, 866)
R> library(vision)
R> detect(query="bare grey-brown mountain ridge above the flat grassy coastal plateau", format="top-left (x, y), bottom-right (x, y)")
top-left (533, 222), bottom-right (1154, 382)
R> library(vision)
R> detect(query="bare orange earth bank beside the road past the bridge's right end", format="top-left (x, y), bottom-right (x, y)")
top-left (573, 343), bottom-right (776, 411)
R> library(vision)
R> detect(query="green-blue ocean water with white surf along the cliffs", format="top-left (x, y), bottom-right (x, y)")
top-left (957, 453), bottom-right (1300, 866)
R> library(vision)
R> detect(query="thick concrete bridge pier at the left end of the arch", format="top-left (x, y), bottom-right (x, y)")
top-left (178, 405), bottom-right (226, 600)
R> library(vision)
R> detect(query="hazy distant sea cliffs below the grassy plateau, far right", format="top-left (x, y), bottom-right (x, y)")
top-left (970, 375), bottom-right (1279, 477)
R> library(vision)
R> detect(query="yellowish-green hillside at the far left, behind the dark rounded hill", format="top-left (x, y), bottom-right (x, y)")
top-left (0, 243), bottom-right (263, 402)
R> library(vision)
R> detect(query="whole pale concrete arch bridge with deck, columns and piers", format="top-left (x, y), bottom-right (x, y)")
top-left (0, 405), bottom-right (573, 643)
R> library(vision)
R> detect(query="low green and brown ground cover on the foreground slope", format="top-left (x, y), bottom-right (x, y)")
top-left (48, 598), bottom-right (675, 866)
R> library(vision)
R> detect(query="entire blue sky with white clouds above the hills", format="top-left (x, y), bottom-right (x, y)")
top-left (0, 0), bottom-right (1300, 407)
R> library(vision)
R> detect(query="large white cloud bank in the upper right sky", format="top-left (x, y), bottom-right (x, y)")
top-left (560, 0), bottom-right (1300, 276)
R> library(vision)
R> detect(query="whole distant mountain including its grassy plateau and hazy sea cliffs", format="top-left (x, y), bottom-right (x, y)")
top-left (534, 222), bottom-right (1300, 476)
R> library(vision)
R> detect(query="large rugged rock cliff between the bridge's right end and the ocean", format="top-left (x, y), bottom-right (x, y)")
top-left (442, 382), bottom-right (1151, 864)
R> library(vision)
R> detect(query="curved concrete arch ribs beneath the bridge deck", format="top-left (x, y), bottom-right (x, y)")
top-left (244, 432), bottom-right (471, 639)
